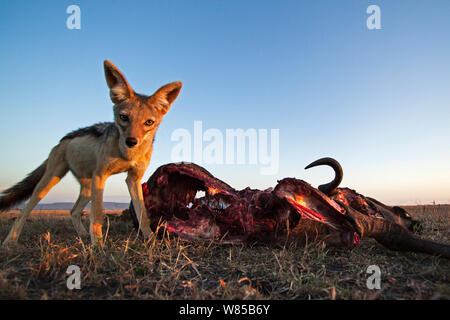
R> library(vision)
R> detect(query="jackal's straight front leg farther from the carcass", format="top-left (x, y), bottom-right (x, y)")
top-left (89, 176), bottom-right (106, 246)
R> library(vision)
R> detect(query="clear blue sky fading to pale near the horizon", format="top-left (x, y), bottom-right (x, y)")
top-left (0, 0), bottom-right (450, 204)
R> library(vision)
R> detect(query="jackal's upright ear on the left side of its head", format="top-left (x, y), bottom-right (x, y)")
top-left (103, 60), bottom-right (133, 103)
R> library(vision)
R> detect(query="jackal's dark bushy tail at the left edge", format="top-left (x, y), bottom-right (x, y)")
top-left (0, 160), bottom-right (47, 212)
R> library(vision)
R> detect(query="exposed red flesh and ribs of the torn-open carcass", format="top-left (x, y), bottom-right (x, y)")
top-left (129, 163), bottom-right (359, 246)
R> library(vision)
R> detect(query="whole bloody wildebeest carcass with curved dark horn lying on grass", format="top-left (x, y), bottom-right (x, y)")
top-left (130, 158), bottom-right (450, 258)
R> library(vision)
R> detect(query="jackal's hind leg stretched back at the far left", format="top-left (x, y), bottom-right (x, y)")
top-left (3, 158), bottom-right (69, 246)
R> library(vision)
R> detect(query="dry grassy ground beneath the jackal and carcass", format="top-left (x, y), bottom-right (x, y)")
top-left (0, 205), bottom-right (450, 299)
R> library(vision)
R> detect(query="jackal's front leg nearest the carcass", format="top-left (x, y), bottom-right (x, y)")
top-left (126, 171), bottom-right (153, 238)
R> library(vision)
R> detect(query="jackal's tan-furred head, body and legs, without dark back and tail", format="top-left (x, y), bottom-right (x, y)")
top-left (4, 60), bottom-right (182, 245)
